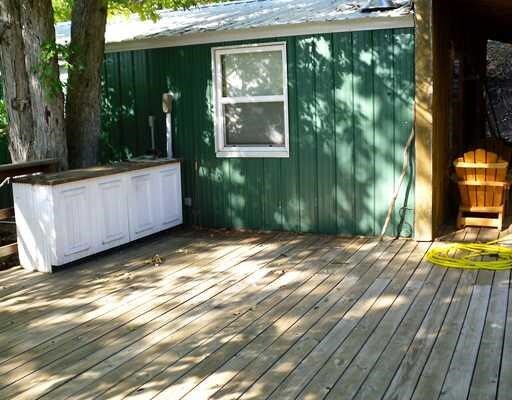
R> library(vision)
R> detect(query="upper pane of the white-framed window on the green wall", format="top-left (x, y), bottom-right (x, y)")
top-left (221, 51), bottom-right (283, 97)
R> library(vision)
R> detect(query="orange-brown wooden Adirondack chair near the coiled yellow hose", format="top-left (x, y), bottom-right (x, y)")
top-left (454, 149), bottom-right (510, 230)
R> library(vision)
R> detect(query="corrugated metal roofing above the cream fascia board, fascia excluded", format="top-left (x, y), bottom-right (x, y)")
top-left (56, 0), bottom-right (412, 49)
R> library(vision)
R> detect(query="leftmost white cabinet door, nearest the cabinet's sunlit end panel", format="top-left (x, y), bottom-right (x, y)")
top-left (55, 185), bottom-right (94, 265)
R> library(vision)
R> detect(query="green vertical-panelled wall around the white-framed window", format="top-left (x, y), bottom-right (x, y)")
top-left (104, 29), bottom-right (414, 236)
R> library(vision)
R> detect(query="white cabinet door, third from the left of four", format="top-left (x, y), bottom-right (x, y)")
top-left (128, 172), bottom-right (156, 240)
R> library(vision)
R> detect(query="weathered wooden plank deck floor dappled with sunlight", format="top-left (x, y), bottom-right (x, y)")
top-left (0, 229), bottom-right (512, 400)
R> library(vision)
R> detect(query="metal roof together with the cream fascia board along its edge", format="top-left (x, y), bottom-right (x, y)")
top-left (56, 0), bottom-right (414, 52)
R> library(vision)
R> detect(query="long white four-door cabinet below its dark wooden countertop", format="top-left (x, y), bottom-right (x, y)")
top-left (13, 163), bottom-right (183, 272)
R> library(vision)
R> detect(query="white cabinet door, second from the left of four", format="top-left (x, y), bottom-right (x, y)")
top-left (95, 176), bottom-right (130, 250)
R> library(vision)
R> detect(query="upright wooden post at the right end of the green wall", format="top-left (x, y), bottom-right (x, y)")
top-left (414, 0), bottom-right (434, 241)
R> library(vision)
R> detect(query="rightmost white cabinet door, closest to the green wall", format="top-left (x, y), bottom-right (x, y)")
top-left (157, 165), bottom-right (183, 229)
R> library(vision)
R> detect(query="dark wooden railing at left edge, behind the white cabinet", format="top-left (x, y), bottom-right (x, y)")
top-left (0, 159), bottom-right (59, 258)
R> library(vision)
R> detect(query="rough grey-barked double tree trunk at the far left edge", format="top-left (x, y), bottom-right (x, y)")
top-left (0, 0), bottom-right (67, 168)
